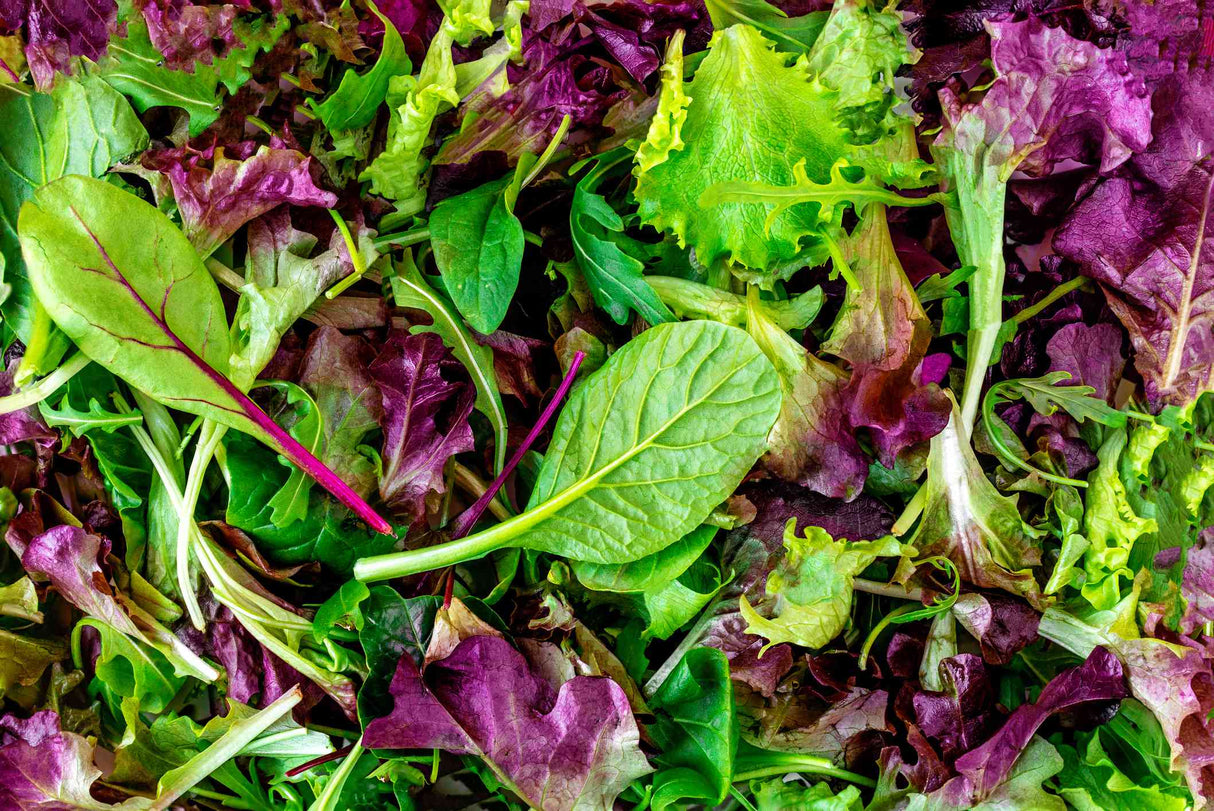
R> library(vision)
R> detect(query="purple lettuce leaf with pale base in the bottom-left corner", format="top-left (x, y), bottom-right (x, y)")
top-left (0, 710), bottom-right (112, 811)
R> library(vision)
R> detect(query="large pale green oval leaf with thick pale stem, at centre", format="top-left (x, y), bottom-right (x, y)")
top-left (354, 321), bottom-right (781, 580)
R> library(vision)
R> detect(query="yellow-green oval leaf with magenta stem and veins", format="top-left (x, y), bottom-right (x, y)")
top-left (19, 175), bottom-right (391, 533)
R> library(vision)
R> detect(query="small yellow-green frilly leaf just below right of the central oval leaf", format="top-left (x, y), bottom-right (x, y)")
top-left (741, 518), bottom-right (908, 650)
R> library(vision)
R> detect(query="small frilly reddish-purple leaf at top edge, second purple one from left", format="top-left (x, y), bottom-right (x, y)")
top-left (142, 0), bottom-right (239, 73)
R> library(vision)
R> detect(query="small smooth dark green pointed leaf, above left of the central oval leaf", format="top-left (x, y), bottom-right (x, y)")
top-left (430, 175), bottom-right (524, 333)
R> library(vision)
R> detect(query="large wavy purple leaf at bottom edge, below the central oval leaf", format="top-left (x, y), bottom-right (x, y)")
top-left (363, 636), bottom-right (652, 811)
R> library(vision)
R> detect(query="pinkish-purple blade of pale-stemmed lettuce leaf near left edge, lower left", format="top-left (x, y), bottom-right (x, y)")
top-left (15, 524), bottom-right (142, 637)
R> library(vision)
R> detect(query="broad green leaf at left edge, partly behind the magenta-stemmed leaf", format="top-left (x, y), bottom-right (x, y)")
top-left (0, 75), bottom-right (148, 359)
